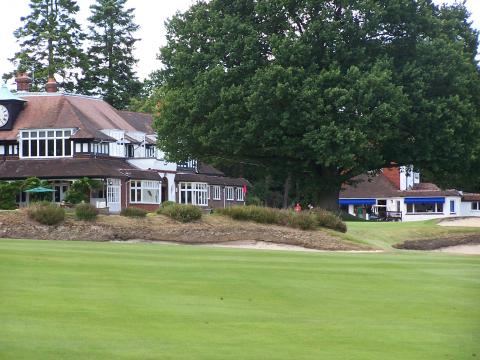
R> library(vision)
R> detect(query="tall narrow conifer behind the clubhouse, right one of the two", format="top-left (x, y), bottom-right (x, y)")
top-left (82, 0), bottom-right (141, 109)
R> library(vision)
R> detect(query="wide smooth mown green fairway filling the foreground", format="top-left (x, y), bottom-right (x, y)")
top-left (0, 240), bottom-right (480, 360)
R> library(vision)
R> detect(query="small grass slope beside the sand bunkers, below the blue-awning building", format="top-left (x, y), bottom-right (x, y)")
top-left (337, 220), bottom-right (480, 250)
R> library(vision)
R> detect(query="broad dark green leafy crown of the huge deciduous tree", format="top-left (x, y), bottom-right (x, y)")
top-left (155, 0), bottom-right (480, 206)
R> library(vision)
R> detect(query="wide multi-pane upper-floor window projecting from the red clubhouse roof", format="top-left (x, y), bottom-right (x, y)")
top-left (20, 129), bottom-right (73, 158)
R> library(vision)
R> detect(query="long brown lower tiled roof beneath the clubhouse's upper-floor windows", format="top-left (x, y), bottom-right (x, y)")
top-left (0, 158), bottom-right (160, 180)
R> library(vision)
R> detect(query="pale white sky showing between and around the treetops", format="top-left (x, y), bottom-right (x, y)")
top-left (0, 0), bottom-right (480, 85)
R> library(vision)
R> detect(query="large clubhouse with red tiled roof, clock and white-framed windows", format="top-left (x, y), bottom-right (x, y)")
top-left (0, 74), bottom-right (249, 213)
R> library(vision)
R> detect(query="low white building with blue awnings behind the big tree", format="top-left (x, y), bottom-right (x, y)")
top-left (339, 166), bottom-right (480, 221)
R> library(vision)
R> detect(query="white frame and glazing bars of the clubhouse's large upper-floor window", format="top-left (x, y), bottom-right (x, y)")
top-left (19, 128), bottom-right (75, 159)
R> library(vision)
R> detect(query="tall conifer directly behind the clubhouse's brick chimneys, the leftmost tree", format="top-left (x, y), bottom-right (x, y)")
top-left (4, 0), bottom-right (84, 91)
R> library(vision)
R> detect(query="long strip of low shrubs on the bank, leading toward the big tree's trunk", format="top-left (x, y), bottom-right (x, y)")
top-left (215, 205), bottom-right (347, 232)
